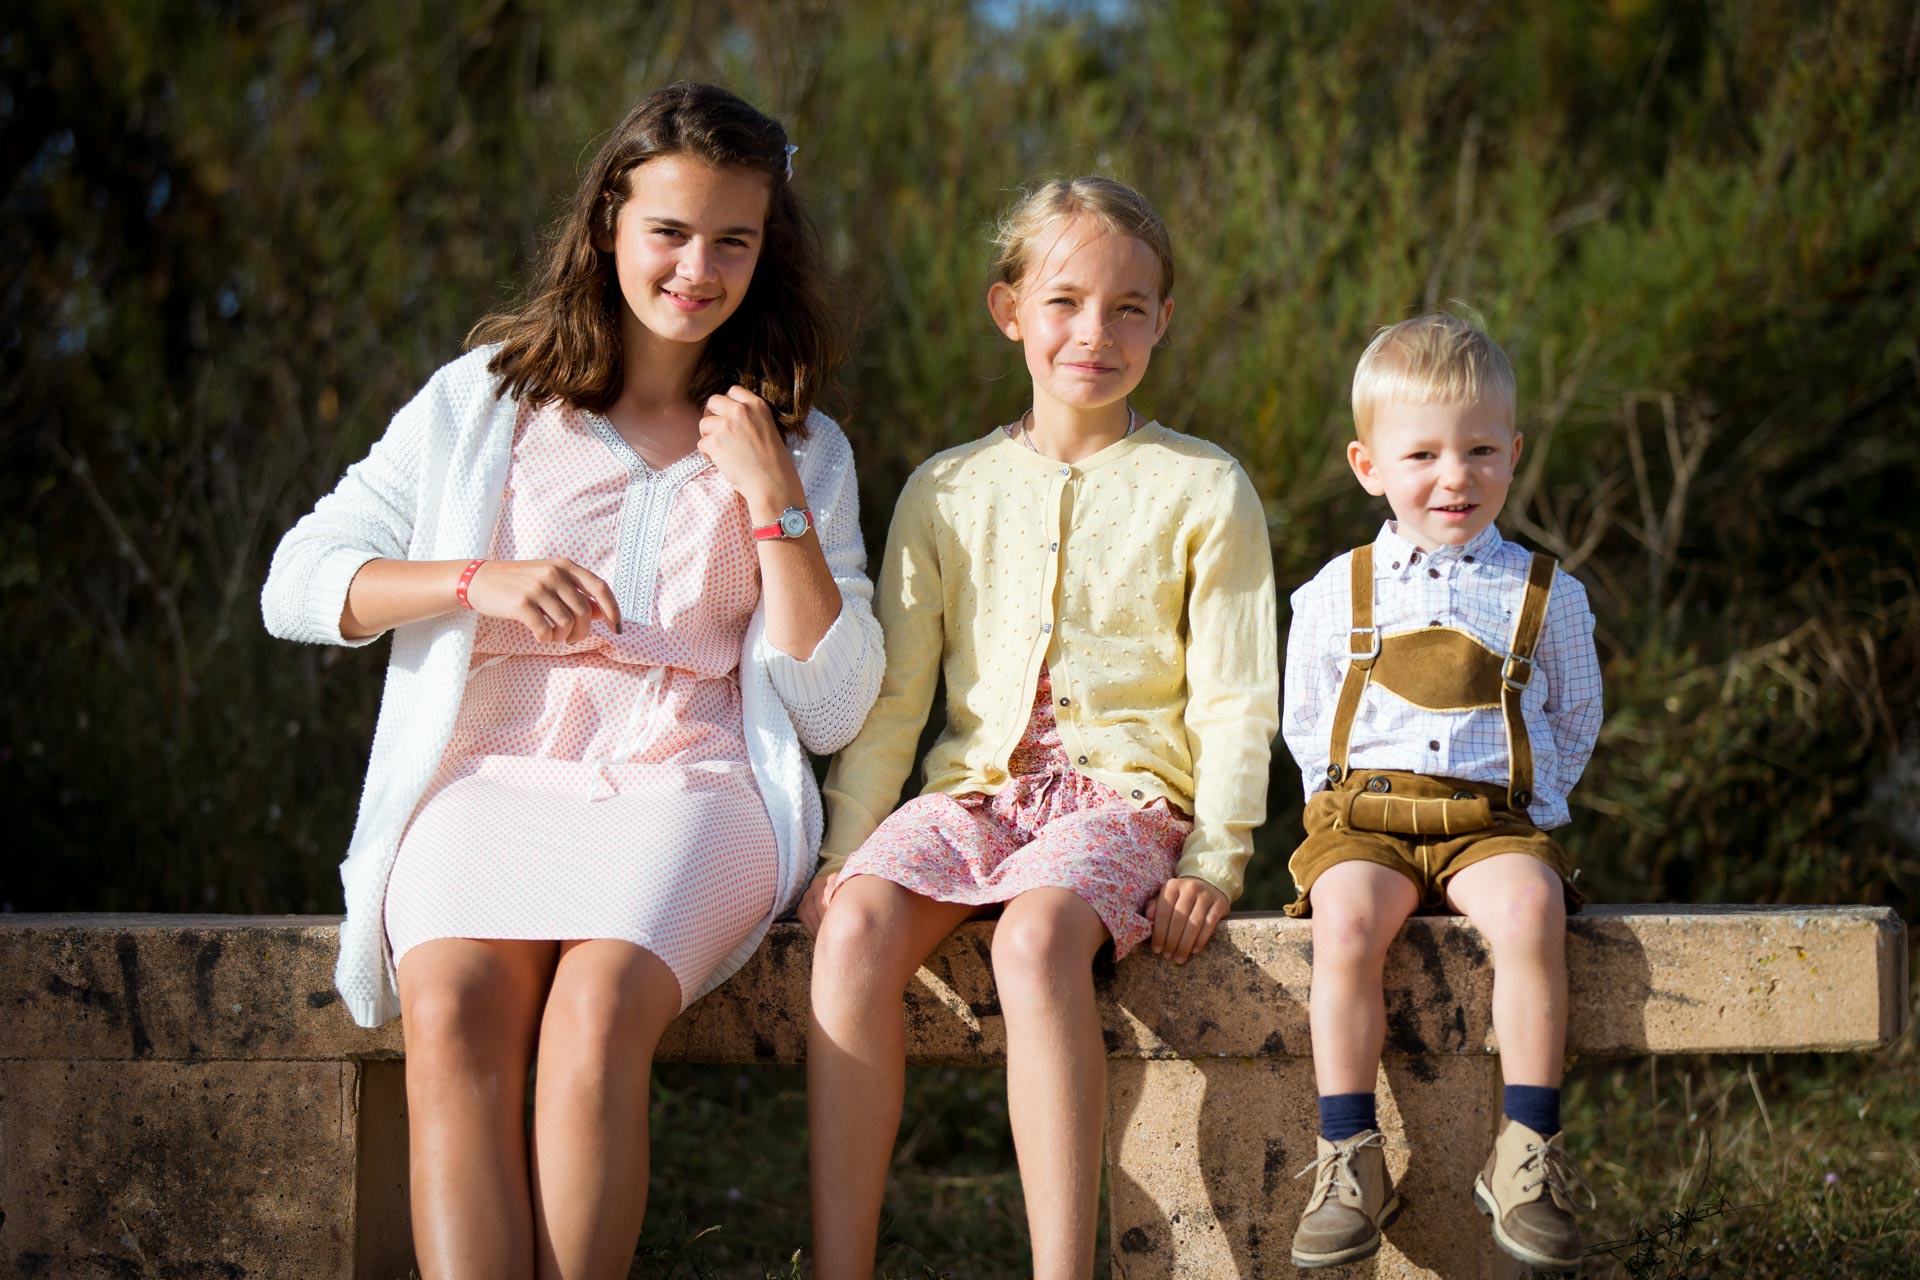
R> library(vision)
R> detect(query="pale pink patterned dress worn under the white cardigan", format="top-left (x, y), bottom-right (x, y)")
top-left (386, 405), bottom-right (778, 994)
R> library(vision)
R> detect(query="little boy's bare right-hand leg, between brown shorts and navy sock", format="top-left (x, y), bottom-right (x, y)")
top-left (1443, 854), bottom-right (1567, 1088)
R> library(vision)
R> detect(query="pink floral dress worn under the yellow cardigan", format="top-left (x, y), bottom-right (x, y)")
top-left (841, 666), bottom-right (1194, 958)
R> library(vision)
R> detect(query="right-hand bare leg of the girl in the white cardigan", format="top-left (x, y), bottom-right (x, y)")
top-left (532, 938), bottom-right (680, 1280)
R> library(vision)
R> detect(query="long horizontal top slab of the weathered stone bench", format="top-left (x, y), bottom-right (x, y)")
top-left (0, 906), bottom-right (1908, 1063)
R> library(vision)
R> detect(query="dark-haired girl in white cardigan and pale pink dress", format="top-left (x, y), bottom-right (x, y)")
top-left (263, 84), bottom-right (883, 1280)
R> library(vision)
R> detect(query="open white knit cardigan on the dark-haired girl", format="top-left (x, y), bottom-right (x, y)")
top-left (261, 347), bottom-right (885, 1027)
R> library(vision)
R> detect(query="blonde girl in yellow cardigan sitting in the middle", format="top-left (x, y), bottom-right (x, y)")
top-left (801, 178), bottom-right (1279, 1280)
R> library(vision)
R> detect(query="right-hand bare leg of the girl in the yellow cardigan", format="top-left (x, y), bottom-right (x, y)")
top-left (993, 889), bottom-right (1108, 1280)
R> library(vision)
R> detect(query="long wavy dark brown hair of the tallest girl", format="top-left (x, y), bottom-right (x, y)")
top-left (467, 81), bottom-right (845, 436)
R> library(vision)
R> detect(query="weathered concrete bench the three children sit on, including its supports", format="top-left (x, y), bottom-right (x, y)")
top-left (0, 908), bottom-right (1908, 1280)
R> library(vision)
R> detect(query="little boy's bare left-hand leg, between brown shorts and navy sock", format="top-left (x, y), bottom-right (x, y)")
top-left (1308, 858), bottom-right (1428, 1096)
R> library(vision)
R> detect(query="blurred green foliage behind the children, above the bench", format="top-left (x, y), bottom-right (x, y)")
top-left (0, 0), bottom-right (1920, 1274)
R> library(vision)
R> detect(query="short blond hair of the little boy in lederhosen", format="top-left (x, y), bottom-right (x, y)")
top-left (1354, 311), bottom-right (1515, 443)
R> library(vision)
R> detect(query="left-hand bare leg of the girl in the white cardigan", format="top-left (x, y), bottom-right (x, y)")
top-left (399, 938), bottom-right (557, 1280)
